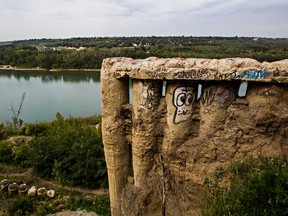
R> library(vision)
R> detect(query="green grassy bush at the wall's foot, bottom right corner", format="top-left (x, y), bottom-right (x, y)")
top-left (203, 158), bottom-right (288, 215)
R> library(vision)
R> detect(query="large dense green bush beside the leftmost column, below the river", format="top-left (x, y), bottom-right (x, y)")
top-left (30, 113), bottom-right (107, 188)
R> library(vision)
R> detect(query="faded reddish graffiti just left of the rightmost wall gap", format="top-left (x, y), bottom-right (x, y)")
top-left (214, 86), bottom-right (236, 109)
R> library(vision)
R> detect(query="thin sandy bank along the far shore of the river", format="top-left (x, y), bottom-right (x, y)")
top-left (0, 65), bottom-right (101, 73)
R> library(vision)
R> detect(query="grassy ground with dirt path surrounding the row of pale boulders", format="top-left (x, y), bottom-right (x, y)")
top-left (0, 169), bottom-right (110, 216)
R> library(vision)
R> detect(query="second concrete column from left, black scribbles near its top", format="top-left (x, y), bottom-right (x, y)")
top-left (132, 80), bottom-right (162, 187)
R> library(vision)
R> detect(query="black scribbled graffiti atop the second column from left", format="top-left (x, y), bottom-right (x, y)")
top-left (139, 81), bottom-right (160, 110)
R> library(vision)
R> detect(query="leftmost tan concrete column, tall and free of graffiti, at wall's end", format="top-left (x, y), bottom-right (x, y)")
top-left (101, 62), bottom-right (131, 216)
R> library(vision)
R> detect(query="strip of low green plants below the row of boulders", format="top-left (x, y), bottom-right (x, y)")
top-left (0, 190), bottom-right (111, 216)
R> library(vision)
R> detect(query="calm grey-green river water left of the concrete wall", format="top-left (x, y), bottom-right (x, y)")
top-left (0, 71), bottom-right (101, 123)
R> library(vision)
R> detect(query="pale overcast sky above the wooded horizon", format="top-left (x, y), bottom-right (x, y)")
top-left (0, 0), bottom-right (288, 41)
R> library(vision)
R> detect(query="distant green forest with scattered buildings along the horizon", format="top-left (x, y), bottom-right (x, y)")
top-left (0, 36), bottom-right (288, 70)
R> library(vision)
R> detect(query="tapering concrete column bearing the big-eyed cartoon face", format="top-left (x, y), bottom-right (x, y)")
top-left (162, 81), bottom-right (198, 154)
